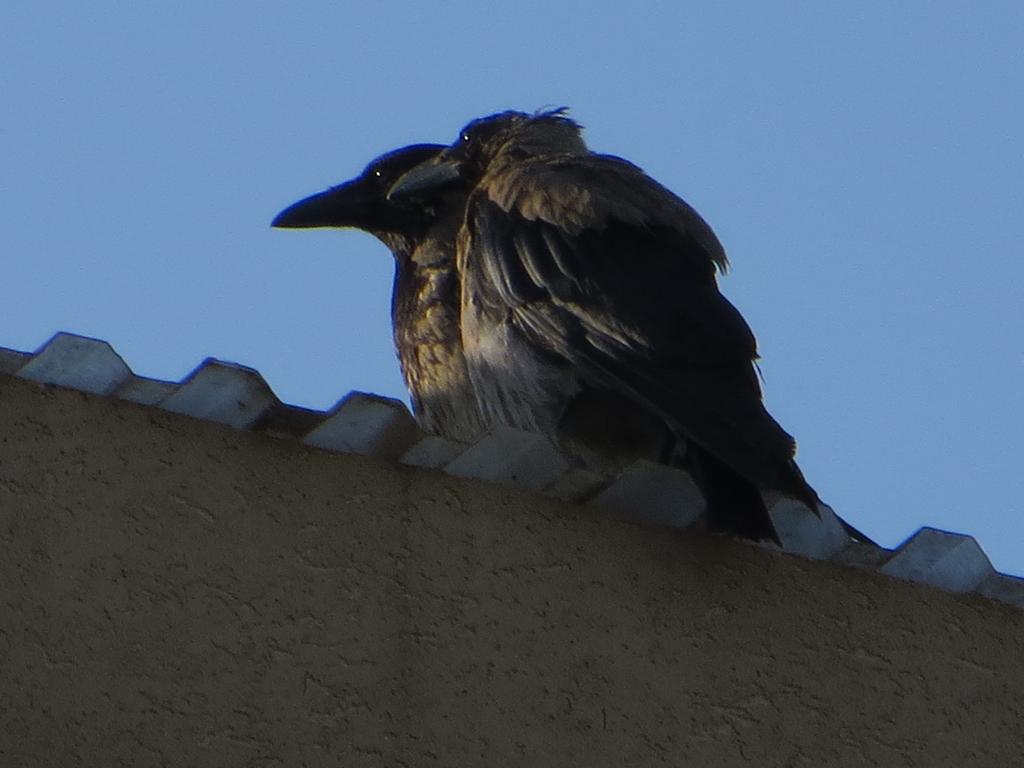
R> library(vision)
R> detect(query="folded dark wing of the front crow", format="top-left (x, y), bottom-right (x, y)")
top-left (460, 156), bottom-right (794, 485)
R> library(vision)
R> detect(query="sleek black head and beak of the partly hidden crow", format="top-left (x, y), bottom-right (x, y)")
top-left (270, 144), bottom-right (454, 246)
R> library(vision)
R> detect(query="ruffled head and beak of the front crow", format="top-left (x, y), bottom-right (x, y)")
top-left (388, 106), bottom-right (588, 200)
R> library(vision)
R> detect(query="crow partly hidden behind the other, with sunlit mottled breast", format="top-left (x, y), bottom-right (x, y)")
top-left (271, 144), bottom-right (486, 443)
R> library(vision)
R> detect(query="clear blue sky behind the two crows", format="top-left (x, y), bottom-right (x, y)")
top-left (0, 0), bottom-right (1024, 573)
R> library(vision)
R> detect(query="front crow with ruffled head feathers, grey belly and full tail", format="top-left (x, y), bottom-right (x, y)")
top-left (388, 108), bottom-right (819, 543)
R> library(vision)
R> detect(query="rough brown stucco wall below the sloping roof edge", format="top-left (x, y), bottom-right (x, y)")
top-left (0, 377), bottom-right (1024, 767)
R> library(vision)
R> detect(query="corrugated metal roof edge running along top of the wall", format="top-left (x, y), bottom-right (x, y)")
top-left (0, 333), bottom-right (1024, 607)
